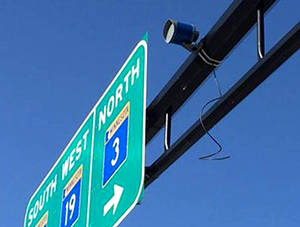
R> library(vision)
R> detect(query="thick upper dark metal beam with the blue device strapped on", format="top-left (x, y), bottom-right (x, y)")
top-left (146, 0), bottom-right (276, 144)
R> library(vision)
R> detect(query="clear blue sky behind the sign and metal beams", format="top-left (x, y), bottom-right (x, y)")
top-left (0, 0), bottom-right (300, 227)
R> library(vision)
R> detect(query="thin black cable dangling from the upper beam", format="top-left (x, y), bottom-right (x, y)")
top-left (199, 70), bottom-right (230, 161)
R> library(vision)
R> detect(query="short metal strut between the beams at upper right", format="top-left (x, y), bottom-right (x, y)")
top-left (257, 2), bottom-right (265, 60)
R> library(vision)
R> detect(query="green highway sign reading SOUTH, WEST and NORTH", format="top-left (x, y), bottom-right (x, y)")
top-left (24, 36), bottom-right (147, 227)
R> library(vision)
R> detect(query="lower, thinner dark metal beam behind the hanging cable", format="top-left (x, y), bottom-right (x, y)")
top-left (145, 22), bottom-right (300, 187)
